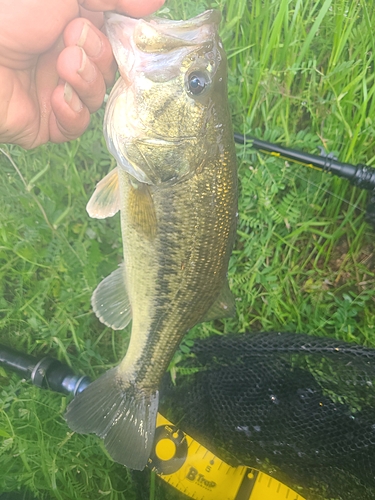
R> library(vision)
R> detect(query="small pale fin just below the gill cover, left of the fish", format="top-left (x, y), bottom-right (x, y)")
top-left (86, 167), bottom-right (120, 219)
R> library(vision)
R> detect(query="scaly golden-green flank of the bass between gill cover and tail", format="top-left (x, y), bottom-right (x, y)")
top-left (121, 145), bottom-right (237, 387)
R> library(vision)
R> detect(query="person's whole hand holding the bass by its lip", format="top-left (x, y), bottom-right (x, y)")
top-left (0, 0), bottom-right (164, 149)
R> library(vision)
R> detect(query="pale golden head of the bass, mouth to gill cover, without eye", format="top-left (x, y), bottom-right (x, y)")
top-left (105, 10), bottom-right (224, 186)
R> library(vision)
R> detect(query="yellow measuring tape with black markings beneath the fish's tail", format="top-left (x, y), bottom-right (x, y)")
top-left (148, 413), bottom-right (305, 500)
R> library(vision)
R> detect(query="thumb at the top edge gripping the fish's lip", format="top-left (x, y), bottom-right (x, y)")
top-left (79, 0), bottom-right (164, 17)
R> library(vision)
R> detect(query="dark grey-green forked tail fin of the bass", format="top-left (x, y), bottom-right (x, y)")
top-left (65, 367), bottom-right (159, 470)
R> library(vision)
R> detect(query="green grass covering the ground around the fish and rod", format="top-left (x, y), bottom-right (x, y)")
top-left (0, 0), bottom-right (375, 500)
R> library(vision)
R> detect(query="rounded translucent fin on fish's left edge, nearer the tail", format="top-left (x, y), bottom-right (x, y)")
top-left (91, 264), bottom-right (131, 330)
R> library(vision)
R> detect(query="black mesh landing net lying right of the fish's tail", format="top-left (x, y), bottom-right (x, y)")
top-left (161, 333), bottom-right (375, 500)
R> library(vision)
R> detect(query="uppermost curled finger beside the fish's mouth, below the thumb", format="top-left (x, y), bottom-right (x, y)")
top-left (64, 18), bottom-right (117, 85)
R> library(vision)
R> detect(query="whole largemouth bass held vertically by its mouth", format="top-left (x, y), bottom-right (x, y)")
top-left (65, 10), bottom-right (237, 470)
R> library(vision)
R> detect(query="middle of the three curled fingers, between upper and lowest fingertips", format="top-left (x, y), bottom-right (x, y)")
top-left (57, 47), bottom-right (106, 113)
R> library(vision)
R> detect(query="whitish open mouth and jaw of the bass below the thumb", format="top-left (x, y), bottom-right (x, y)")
top-left (105, 10), bottom-right (221, 84)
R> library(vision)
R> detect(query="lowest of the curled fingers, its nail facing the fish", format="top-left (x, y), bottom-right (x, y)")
top-left (49, 83), bottom-right (90, 142)
